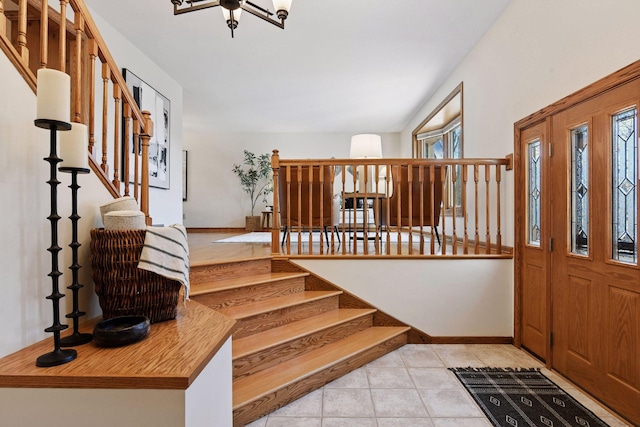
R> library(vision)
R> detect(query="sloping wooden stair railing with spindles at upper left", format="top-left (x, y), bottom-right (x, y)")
top-left (0, 0), bottom-right (153, 224)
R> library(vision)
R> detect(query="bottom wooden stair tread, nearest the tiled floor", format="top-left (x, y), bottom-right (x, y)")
top-left (233, 326), bottom-right (411, 410)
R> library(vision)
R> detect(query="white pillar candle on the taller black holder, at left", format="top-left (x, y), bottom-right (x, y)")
top-left (36, 68), bottom-right (71, 123)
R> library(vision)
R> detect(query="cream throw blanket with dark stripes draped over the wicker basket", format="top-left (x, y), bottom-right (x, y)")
top-left (138, 224), bottom-right (189, 300)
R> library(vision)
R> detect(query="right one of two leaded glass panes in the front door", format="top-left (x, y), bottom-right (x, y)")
top-left (611, 108), bottom-right (638, 264)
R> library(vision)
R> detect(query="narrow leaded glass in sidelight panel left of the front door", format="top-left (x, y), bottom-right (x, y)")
top-left (527, 139), bottom-right (542, 246)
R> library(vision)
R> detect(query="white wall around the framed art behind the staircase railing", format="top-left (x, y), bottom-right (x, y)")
top-left (92, 11), bottom-right (183, 225)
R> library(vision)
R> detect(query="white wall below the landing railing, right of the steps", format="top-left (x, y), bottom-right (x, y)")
top-left (296, 259), bottom-right (513, 337)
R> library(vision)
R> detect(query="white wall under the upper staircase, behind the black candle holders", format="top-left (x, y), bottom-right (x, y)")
top-left (0, 54), bottom-right (112, 363)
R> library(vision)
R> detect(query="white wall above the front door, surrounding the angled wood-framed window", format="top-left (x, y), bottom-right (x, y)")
top-left (402, 0), bottom-right (640, 244)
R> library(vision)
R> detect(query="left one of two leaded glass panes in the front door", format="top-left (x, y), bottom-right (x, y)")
top-left (571, 125), bottom-right (589, 255)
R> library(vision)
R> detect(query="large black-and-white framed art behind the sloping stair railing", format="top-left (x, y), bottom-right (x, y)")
top-left (122, 68), bottom-right (171, 190)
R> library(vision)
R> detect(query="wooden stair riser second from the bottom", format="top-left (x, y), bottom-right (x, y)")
top-left (233, 315), bottom-right (373, 379)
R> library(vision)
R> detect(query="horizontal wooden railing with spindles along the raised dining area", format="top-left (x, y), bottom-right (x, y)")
top-left (272, 150), bottom-right (512, 257)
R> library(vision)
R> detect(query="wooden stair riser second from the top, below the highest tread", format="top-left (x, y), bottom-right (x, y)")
top-left (192, 277), bottom-right (304, 310)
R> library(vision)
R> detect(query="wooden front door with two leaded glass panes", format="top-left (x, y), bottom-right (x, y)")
top-left (549, 80), bottom-right (640, 424)
